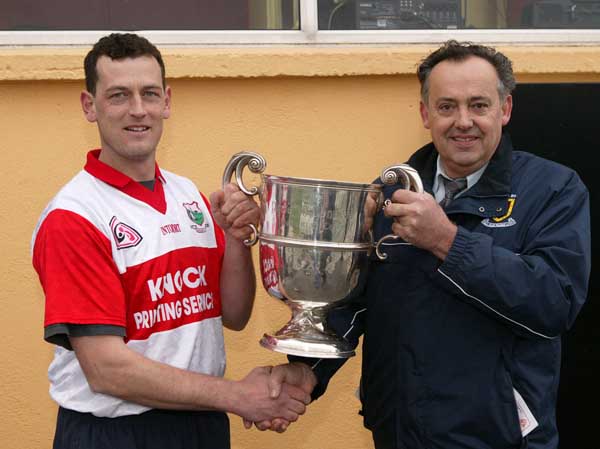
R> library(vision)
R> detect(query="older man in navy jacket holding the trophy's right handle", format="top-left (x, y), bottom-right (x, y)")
top-left (259, 41), bottom-right (591, 449)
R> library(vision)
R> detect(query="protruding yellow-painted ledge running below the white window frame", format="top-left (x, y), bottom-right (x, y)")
top-left (0, 45), bottom-right (600, 81)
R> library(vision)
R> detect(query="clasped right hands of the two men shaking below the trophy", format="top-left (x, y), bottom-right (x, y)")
top-left (231, 362), bottom-right (317, 433)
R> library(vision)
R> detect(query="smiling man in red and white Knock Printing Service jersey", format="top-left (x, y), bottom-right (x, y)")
top-left (32, 34), bottom-right (313, 449)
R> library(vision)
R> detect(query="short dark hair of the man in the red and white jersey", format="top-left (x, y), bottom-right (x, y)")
top-left (83, 33), bottom-right (166, 95)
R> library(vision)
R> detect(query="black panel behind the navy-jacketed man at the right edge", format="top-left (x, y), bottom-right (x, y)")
top-left (506, 83), bottom-right (600, 449)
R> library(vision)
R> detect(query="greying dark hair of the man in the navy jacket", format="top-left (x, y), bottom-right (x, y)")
top-left (417, 40), bottom-right (516, 101)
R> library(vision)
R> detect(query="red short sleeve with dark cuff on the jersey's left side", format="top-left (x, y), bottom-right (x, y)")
top-left (33, 209), bottom-right (126, 349)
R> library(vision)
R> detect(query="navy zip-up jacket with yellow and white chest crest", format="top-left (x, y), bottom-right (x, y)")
top-left (298, 134), bottom-right (591, 449)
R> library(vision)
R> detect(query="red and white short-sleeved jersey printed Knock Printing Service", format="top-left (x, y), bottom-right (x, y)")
top-left (32, 150), bottom-right (225, 417)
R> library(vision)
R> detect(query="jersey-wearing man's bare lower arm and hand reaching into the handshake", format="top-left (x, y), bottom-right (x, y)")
top-left (71, 336), bottom-right (310, 421)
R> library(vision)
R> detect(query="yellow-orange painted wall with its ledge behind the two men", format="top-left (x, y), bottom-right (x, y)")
top-left (0, 47), bottom-right (600, 449)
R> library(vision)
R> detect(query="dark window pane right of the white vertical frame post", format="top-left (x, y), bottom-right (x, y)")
top-left (318, 0), bottom-right (600, 30)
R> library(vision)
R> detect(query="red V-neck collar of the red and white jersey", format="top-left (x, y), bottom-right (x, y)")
top-left (84, 149), bottom-right (167, 214)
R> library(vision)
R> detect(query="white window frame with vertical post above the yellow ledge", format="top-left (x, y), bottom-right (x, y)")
top-left (0, 0), bottom-right (600, 47)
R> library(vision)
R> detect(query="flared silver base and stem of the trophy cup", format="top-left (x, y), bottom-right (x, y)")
top-left (260, 301), bottom-right (355, 359)
